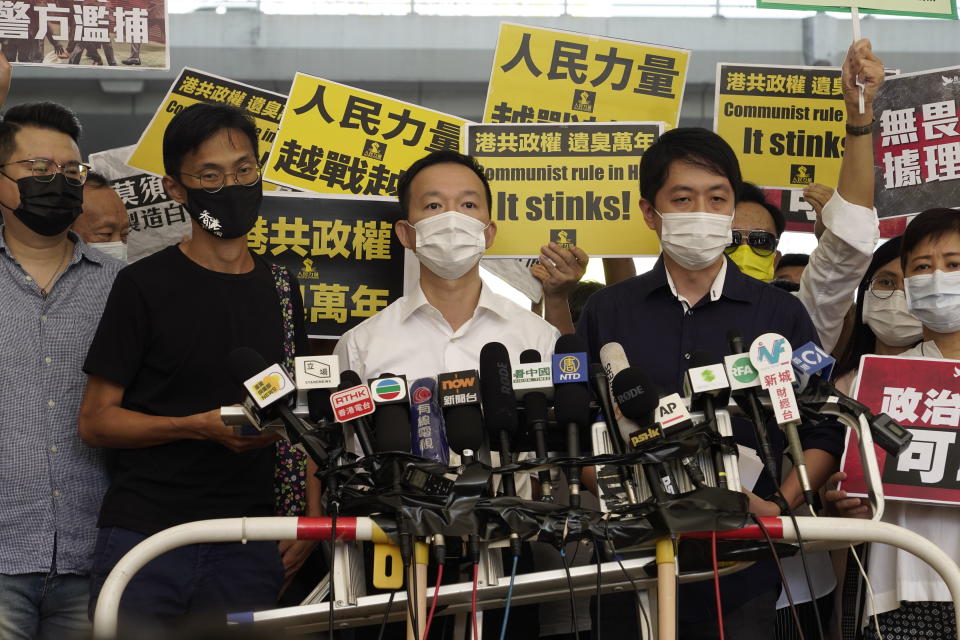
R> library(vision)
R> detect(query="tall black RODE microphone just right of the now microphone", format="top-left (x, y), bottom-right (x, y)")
top-left (480, 342), bottom-right (518, 497)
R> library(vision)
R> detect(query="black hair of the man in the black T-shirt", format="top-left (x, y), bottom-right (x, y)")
top-left (163, 102), bottom-right (260, 180)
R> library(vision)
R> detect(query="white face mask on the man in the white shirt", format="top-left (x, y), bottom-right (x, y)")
top-left (408, 211), bottom-right (490, 280)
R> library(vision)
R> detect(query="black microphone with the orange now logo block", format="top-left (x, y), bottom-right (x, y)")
top-left (437, 369), bottom-right (483, 464)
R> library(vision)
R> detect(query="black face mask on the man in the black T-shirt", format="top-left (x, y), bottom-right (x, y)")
top-left (185, 183), bottom-right (263, 240)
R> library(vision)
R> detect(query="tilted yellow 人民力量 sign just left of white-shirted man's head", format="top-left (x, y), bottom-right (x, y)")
top-left (264, 73), bottom-right (466, 195)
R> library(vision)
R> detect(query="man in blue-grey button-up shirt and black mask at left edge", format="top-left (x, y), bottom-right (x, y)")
top-left (0, 102), bottom-right (123, 640)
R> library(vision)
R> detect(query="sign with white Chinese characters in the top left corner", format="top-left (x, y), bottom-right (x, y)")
top-left (0, 0), bottom-right (170, 71)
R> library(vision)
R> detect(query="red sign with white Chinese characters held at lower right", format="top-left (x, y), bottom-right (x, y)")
top-left (841, 356), bottom-right (960, 504)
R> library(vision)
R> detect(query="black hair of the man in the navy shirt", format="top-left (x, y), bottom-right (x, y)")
top-left (640, 127), bottom-right (743, 203)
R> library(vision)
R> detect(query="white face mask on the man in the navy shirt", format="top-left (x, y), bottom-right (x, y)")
top-left (653, 209), bottom-right (733, 271)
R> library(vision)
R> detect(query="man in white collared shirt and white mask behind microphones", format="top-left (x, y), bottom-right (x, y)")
top-left (334, 151), bottom-right (559, 380)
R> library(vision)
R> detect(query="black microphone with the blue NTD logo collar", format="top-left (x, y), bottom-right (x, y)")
top-left (553, 333), bottom-right (590, 507)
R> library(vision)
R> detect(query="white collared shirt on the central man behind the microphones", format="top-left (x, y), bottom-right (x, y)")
top-left (334, 284), bottom-right (560, 382)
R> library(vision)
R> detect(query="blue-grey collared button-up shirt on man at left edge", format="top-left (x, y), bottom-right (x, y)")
top-left (0, 225), bottom-right (123, 575)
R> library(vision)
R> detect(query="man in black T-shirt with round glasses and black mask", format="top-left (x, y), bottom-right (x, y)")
top-left (80, 104), bottom-right (305, 629)
